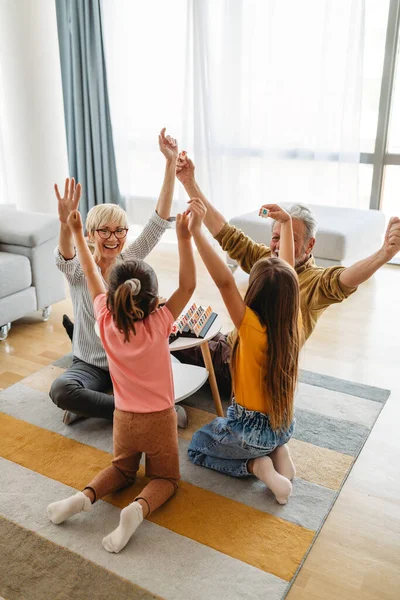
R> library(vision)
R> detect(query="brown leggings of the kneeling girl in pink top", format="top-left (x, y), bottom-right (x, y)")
top-left (85, 407), bottom-right (180, 513)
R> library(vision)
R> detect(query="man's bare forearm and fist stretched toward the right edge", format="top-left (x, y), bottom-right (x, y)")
top-left (340, 217), bottom-right (400, 288)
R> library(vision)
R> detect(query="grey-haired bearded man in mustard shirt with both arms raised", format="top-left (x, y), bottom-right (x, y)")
top-left (174, 158), bottom-right (400, 394)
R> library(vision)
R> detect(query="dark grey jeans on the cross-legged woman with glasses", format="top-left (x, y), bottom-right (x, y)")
top-left (50, 356), bottom-right (114, 421)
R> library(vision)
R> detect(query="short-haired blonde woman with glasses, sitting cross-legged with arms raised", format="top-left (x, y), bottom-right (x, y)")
top-left (50, 129), bottom-right (178, 425)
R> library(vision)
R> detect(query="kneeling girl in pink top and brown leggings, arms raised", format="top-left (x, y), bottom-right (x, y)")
top-left (47, 211), bottom-right (196, 552)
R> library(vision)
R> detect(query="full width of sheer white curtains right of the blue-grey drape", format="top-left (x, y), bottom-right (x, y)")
top-left (104, 0), bottom-right (364, 218)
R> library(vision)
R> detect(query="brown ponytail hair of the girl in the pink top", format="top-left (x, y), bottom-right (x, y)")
top-left (107, 259), bottom-right (158, 342)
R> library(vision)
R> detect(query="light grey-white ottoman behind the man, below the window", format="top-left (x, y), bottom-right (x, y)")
top-left (228, 204), bottom-right (385, 267)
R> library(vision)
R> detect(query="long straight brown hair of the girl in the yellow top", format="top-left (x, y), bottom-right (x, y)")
top-left (231, 258), bottom-right (300, 429)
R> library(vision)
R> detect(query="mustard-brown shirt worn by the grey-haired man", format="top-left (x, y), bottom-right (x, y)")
top-left (215, 223), bottom-right (357, 342)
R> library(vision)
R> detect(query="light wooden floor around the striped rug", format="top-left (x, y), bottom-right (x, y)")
top-left (0, 244), bottom-right (400, 600)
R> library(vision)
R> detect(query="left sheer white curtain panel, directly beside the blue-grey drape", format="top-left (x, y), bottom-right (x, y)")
top-left (103, 0), bottom-right (187, 224)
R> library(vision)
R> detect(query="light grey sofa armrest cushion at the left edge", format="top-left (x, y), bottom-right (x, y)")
top-left (0, 209), bottom-right (60, 248)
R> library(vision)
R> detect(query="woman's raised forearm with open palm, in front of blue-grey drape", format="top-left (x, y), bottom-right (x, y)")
top-left (54, 178), bottom-right (82, 260)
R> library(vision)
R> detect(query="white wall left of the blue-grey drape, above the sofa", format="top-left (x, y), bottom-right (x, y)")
top-left (0, 0), bottom-right (68, 213)
